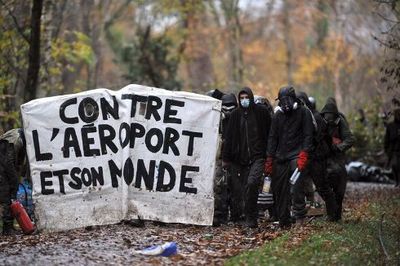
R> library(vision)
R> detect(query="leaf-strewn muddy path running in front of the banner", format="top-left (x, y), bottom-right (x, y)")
top-left (0, 183), bottom-right (393, 265)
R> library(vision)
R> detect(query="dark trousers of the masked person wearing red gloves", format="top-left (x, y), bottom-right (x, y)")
top-left (271, 160), bottom-right (296, 226)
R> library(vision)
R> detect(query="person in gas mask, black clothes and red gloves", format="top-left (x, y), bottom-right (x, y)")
top-left (264, 86), bottom-right (314, 228)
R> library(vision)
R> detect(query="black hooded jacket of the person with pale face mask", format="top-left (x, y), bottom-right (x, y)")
top-left (222, 88), bottom-right (271, 165)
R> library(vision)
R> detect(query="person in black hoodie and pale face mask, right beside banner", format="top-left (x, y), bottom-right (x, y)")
top-left (222, 87), bottom-right (271, 228)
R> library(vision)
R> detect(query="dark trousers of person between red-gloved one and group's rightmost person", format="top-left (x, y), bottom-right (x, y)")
top-left (309, 159), bottom-right (338, 220)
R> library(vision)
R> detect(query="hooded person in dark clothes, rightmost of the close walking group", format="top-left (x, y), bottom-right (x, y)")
top-left (321, 98), bottom-right (354, 220)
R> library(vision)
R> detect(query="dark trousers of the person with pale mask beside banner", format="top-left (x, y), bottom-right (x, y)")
top-left (229, 159), bottom-right (264, 221)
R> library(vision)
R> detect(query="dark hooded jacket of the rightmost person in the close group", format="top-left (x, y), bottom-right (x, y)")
top-left (321, 98), bottom-right (354, 156)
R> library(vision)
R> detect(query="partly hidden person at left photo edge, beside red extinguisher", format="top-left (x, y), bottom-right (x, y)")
top-left (0, 139), bottom-right (18, 235)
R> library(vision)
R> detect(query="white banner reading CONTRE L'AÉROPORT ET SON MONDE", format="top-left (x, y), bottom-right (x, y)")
top-left (21, 85), bottom-right (221, 231)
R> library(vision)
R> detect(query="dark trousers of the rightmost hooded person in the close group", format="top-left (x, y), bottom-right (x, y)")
top-left (327, 158), bottom-right (347, 220)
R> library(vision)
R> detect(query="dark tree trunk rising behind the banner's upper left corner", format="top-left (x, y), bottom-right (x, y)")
top-left (24, 0), bottom-right (43, 102)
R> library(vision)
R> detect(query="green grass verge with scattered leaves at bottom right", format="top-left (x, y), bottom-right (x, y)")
top-left (226, 194), bottom-right (400, 265)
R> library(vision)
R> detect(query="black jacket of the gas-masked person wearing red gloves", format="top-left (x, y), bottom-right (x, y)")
top-left (268, 105), bottom-right (314, 162)
